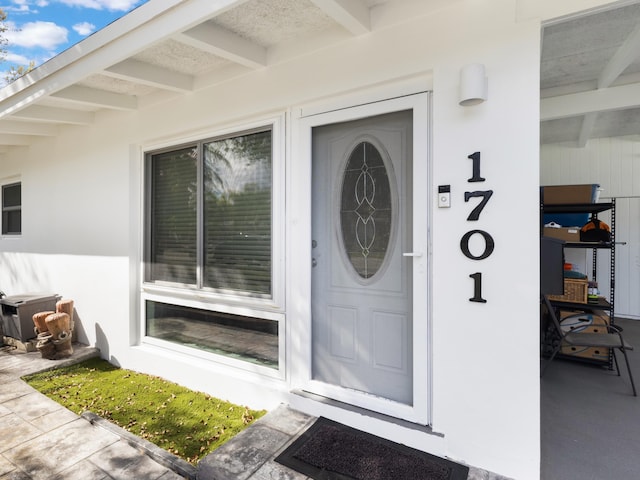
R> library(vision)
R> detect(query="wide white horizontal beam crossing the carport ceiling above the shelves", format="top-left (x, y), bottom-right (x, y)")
top-left (540, 84), bottom-right (640, 121)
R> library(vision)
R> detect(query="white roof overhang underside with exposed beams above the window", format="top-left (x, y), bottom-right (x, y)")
top-left (0, 0), bottom-right (444, 152)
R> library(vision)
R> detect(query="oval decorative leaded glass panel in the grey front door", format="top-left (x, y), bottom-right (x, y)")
top-left (340, 141), bottom-right (393, 279)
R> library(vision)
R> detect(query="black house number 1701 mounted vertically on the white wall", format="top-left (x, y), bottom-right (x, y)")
top-left (460, 152), bottom-right (495, 303)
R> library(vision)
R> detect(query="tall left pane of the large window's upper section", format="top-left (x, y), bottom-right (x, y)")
top-left (146, 146), bottom-right (198, 284)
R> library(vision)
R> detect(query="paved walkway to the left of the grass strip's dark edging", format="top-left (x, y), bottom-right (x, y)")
top-left (0, 346), bottom-right (186, 480)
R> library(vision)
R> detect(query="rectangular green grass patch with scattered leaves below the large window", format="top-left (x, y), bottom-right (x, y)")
top-left (24, 358), bottom-right (266, 464)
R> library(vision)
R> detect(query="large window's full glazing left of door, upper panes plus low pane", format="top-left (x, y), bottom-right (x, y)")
top-left (143, 126), bottom-right (279, 369)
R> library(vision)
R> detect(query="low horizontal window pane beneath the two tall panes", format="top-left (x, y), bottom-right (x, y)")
top-left (146, 301), bottom-right (278, 368)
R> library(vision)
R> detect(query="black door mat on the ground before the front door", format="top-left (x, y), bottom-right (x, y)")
top-left (276, 417), bottom-right (469, 480)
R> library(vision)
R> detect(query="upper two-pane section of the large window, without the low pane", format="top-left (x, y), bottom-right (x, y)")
top-left (146, 129), bottom-right (272, 298)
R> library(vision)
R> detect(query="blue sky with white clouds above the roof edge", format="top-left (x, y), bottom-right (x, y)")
top-left (0, 0), bottom-right (146, 72)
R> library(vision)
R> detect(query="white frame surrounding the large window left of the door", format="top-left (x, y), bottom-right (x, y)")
top-left (139, 114), bottom-right (286, 378)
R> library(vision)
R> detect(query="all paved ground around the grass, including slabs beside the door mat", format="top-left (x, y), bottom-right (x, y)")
top-left (0, 345), bottom-right (508, 480)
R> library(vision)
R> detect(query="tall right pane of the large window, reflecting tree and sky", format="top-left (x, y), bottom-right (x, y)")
top-left (203, 130), bottom-right (271, 296)
